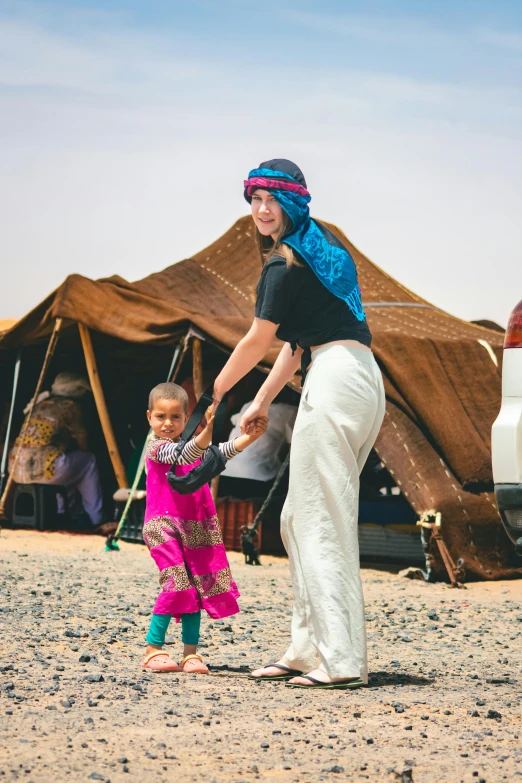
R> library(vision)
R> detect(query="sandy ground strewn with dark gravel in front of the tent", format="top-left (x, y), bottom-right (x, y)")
top-left (0, 530), bottom-right (522, 783)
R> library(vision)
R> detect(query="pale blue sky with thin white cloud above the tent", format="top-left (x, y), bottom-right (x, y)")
top-left (0, 0), bottom-right (522, 324)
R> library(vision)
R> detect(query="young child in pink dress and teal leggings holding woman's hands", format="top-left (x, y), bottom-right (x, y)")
top-left (142, 383), bottom-right (268, 674)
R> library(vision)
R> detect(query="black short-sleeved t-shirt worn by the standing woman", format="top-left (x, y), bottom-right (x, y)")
top-left (256, 254), bottom-right (372, 348)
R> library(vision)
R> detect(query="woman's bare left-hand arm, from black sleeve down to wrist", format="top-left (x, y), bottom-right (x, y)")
top-left (214, 318), bottom-right (278, 400)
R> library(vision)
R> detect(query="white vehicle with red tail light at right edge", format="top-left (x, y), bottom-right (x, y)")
top-left (491, 302), bottom-right (522, 555)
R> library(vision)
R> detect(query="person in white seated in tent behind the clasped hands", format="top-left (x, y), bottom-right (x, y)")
top-left (219, 402), bottom-right (297, 500)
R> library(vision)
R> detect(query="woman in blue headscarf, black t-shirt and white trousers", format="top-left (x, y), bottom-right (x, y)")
top-left (214, 160), bottom-right (385, 688)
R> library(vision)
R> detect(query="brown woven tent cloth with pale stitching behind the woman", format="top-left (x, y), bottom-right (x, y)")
top-left (0, 217), bottom-right (512, 579)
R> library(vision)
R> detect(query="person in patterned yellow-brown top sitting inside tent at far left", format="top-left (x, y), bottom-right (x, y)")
top-left (9, 372), bottom-right (115, 534)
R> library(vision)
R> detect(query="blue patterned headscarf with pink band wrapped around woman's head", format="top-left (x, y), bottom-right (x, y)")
top-left (244, 159), bottom-right (365, 321)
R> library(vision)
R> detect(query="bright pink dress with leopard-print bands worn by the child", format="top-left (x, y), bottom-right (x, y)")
top-left (143, 439), bottom-right (239, 620)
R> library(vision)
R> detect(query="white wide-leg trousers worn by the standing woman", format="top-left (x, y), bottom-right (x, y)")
top-left (281, 345), bottom-right (385, 683)
